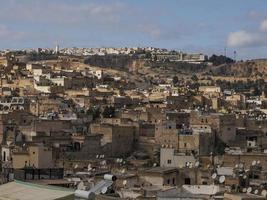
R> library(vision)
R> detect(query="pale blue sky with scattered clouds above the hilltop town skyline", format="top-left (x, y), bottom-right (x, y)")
top-left (0, 0), bottom-right (267, 59)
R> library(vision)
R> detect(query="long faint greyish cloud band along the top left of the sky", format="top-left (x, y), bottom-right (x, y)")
top-left (0, 0), bottom-right (125, 25)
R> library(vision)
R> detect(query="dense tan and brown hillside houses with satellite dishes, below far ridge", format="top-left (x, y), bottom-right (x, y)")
top-left (0, 52), bottom-right (267, 200)
